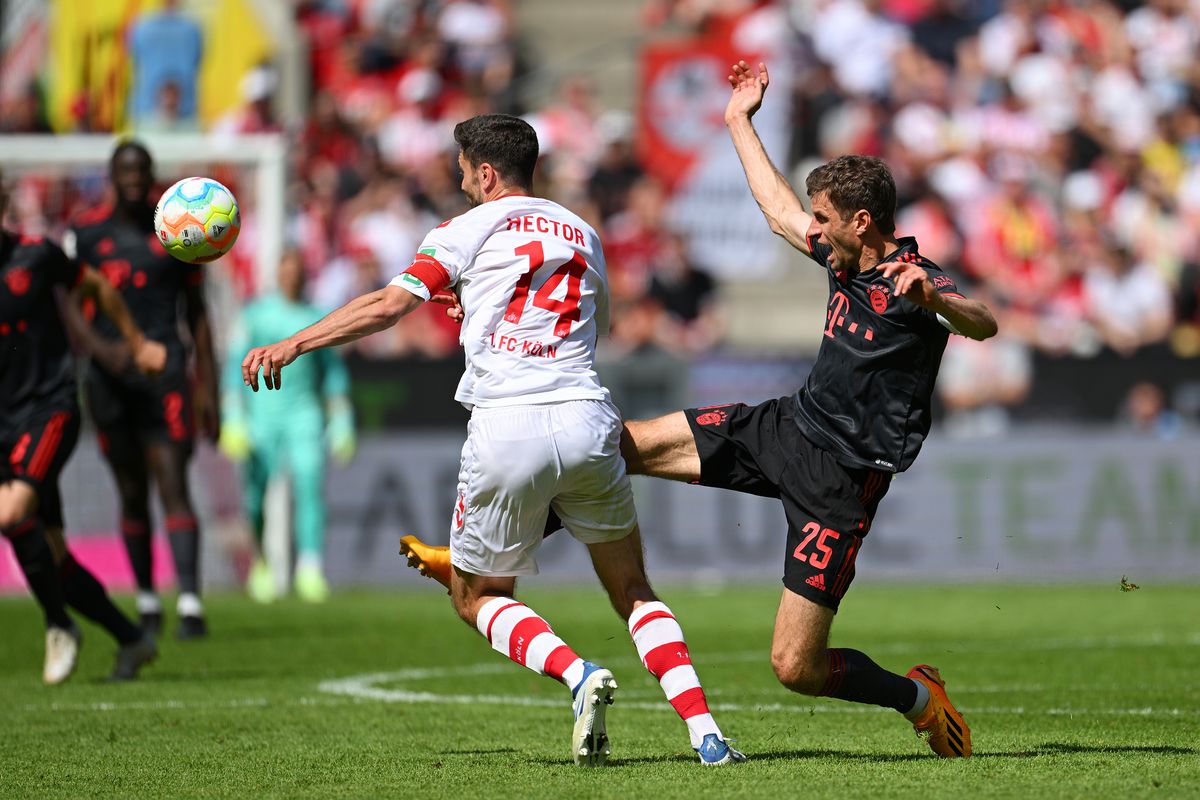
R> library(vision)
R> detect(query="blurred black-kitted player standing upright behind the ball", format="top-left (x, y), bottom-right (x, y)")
top-left (67, 140), bottom-right (220, 638)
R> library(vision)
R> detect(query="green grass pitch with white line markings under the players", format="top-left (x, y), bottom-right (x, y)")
top-left (0, 582), bottom-right (1200, 800)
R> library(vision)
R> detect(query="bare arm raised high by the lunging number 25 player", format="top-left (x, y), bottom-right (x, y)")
top-left (725, 61), bottom-right (812, 253)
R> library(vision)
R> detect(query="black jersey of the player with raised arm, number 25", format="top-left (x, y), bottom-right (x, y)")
top-left (794, 237), bottom-right (962, 473)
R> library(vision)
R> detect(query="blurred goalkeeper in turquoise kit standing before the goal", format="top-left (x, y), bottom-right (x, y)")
top-left (221, 251), bottom-right (354, 602)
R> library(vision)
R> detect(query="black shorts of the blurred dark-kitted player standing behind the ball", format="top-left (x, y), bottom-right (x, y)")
top-left (84, 366), bottom-right (196, 446)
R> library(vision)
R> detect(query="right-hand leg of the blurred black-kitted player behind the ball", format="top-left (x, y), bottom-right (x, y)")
top-left (146, 441), bottom-right (208, 639)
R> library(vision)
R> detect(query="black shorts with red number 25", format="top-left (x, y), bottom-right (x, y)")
top-left (684, 397), bottom-right (892, 610)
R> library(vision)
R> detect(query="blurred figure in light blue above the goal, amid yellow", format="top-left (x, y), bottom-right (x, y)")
top-left (127, 0), bottom-right (204, 126)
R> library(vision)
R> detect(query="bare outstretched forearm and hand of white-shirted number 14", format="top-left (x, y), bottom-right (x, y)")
top-left (241, 287), bottom-right (425, 392)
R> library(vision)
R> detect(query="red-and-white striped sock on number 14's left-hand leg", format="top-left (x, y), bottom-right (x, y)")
top-left (475, 597), bottom-right (583, 690)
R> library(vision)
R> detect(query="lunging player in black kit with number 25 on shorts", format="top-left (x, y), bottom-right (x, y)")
top-left (402, 61), bottom-right (996, 758)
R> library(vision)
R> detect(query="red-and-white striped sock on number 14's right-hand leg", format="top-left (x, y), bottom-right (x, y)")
top-left (629, 601), bottom-right (725, 747)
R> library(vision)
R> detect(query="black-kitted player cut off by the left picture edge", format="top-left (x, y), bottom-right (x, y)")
top-left (0, 172), bottom-right (167, 684)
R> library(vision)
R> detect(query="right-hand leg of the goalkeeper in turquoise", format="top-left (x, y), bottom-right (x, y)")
top-left (287, 427), bottom-right (329, 603)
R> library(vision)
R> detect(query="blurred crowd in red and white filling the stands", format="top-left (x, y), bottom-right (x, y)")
top-left (7, 0), bottom-right (1200, 381)
